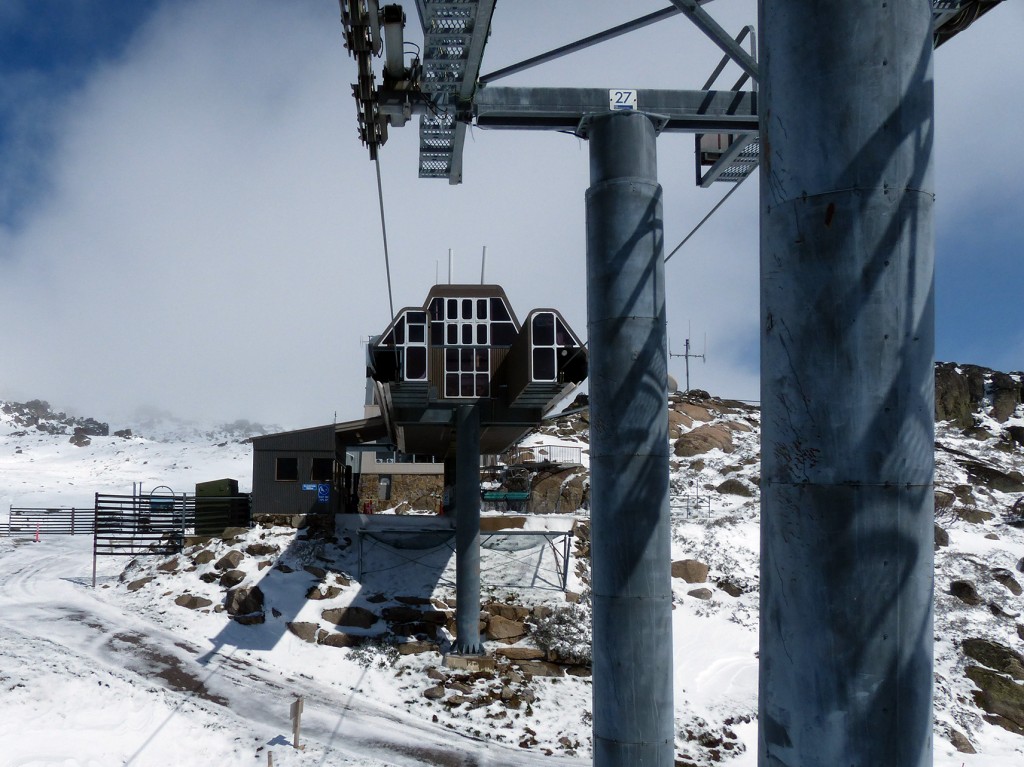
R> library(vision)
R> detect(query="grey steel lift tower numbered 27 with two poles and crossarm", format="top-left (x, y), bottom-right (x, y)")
top-left (341, 0), bottom-right (999, 767)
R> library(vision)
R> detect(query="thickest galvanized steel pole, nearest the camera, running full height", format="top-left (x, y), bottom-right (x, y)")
top-left (759, 0), bottom-right (935, 767)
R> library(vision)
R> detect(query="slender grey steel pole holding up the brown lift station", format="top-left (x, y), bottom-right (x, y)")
top-left (455, 404), bottom-right (483, 655)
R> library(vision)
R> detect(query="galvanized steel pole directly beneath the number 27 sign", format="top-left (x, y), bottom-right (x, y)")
top-left (587, 112), bottom-right (675, 767)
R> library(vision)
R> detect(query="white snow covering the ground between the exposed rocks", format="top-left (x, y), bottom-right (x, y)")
top-left (0, 391), bottom-right (1024, 767)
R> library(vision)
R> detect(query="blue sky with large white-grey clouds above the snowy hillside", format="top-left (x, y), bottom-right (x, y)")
top-left (0, 0), bottom-right (1024, 428)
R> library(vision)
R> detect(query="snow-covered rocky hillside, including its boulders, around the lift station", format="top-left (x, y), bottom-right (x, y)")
top-left (0, 368), bottom-right (1024, 767)
